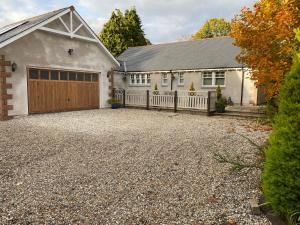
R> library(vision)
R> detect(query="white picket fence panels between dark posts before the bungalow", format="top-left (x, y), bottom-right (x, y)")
top-left (115, 90), bottom-right (215, 111)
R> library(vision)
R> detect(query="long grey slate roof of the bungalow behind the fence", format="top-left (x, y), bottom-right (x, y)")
top-left (118, 37), bottom-right (242, 72)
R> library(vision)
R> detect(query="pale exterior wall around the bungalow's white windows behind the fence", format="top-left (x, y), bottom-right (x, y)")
top-left (114, 70), bottom-right (257, 105)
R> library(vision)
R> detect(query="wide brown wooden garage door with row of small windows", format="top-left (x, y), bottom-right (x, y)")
top-left (28, 68), bottom-right (99, 113)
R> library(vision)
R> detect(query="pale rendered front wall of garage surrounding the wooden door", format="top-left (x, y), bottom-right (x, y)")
top-left (0, 31), bottom-right (115, 115)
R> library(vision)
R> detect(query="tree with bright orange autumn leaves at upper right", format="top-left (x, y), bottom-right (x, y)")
top-left (231, 0), bottom-right (300, 101)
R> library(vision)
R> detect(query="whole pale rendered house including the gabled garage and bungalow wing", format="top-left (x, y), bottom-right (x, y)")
top-left (0, 6), bottom-right (257, 120)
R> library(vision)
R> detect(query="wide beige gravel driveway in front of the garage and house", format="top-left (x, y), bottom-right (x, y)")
top-left (0, 109), bottom-right (270, 225)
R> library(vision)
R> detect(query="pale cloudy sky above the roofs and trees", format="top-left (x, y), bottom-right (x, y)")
top-left (0, 0), bottom-right (255, 43)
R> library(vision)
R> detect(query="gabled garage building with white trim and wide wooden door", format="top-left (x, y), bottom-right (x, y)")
top-left (0, 6), bottom-right (120, 120)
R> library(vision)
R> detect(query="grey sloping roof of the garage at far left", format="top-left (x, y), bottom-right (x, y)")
top-left (0, 7), bottom-right (68, 43)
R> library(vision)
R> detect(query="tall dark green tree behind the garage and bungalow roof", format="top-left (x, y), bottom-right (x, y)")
top-left (99, 8), bottom-right (151, 56)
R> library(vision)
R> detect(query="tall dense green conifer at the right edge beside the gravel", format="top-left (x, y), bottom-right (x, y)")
top-left (263, 30), bottom-right (300, 220)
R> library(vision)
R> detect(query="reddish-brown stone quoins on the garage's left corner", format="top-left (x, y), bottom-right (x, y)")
top-left (0, 55), bottom-right (13, 121)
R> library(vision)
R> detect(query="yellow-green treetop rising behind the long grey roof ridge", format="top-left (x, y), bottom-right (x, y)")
top-left (192, 18), bottom-right (231, 40)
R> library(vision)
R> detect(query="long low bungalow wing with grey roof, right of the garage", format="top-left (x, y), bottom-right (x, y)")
top-left (114, 37), bottom-right (257, 105)
